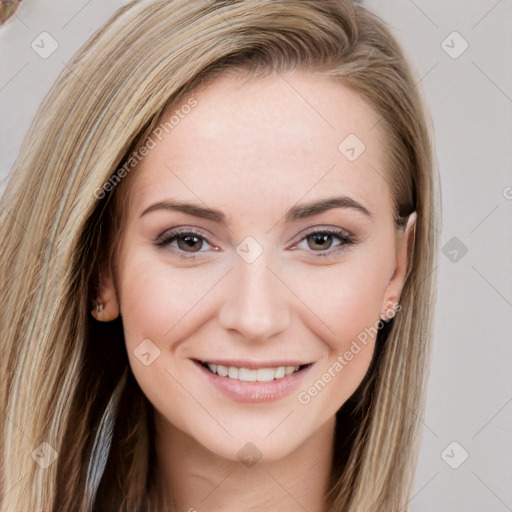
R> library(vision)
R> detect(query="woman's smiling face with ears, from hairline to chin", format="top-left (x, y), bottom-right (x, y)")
top-left (97, 72), bottom-right (412, 460)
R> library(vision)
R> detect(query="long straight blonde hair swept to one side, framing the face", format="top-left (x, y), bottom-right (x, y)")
top-left (0, 0), bottom-right (440, 512)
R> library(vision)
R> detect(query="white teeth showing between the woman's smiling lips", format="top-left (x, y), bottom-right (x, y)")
top-left (196, 361), bottom-right (313, 382)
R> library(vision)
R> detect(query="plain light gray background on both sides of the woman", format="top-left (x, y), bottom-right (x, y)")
top-left (0, 0), bottom-right (512, 512)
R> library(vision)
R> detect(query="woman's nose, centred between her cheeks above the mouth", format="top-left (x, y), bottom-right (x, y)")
top-left (219, 252), bottom-right (291, 341)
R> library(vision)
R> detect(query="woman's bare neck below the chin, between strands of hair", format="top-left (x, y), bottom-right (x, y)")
top-left (155, 414), bottom-right (335, 512)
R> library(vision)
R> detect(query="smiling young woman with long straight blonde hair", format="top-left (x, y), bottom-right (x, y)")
top-left (0, 0), bottom-right (439, 512)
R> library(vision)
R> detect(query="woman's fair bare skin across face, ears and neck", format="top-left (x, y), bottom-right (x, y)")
top-left (98, 72), bottom-right (414, 512)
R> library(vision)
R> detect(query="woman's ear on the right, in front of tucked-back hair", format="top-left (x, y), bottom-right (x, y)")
top-left (380, 212), bottom-right (416, 320)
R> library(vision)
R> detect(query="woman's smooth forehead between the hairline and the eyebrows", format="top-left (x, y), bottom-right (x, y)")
top-left (126, 72), bottom-right (391, 220)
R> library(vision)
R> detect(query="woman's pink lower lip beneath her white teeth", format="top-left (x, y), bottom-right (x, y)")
top-left (194, 361), bottom-right (312, 403)
